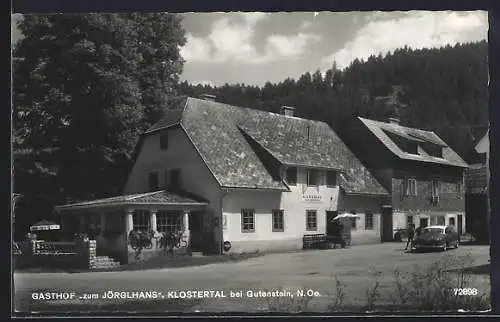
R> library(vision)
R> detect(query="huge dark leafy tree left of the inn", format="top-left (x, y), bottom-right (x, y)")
top-left (13, 14), bottom-right (188, 238)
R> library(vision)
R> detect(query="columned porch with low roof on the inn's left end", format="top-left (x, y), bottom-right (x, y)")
top-left (56, 190), bottom-right (208, 263)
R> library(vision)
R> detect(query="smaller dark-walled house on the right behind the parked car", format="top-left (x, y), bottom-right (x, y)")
top-left (339, 116), bottom-right (468, 241)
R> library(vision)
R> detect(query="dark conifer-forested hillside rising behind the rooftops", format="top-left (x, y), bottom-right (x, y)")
top-left (179, 41), bottom-right (488, 159)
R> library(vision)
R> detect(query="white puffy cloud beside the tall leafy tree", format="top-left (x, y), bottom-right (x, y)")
top-left (181, 12), bottom-right (319, 64)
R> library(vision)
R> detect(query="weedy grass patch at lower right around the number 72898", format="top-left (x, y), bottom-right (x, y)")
top-left (244, 255), bottom-right (491, 313)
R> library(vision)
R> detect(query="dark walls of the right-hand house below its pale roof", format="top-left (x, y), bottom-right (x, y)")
top-left (337, 118), bottom-right (465, 240)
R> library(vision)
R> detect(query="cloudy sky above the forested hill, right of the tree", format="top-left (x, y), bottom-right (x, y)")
top-left (11, 11), bottom-right (488, 85)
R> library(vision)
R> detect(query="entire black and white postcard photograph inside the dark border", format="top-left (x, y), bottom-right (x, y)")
top-left (11, 10), bottom-right (491, 316)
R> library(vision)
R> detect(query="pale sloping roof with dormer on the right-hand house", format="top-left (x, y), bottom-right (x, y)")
top-left (359, 117), bottom-right (468, 168)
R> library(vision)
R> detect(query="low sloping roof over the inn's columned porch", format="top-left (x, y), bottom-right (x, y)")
top-left (55, 190), bottom-right (208, 211)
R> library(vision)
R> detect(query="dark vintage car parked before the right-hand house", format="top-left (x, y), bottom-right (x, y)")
top-left (413, 226), bottom-right (459, 251)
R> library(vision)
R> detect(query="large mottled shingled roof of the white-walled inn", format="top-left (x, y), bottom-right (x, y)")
top-left (146, 98), bottom-right (387, 194)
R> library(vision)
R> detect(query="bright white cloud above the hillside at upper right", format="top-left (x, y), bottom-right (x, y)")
top-left (322, 11), bottom-right (488, 68)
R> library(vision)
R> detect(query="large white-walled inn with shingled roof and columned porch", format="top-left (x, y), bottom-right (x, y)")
top-left (57, 97), bottom-right (388, 261)
